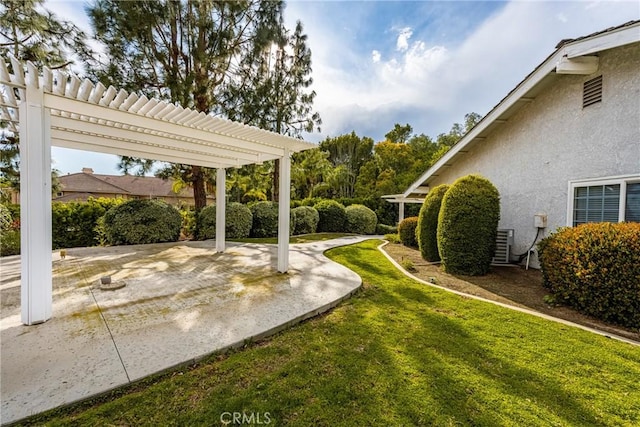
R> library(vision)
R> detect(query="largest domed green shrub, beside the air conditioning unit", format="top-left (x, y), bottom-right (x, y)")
top-left (437, 175), bottom-right (500, 276)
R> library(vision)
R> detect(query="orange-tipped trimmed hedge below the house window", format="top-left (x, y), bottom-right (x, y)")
top-left (538, 223), bottom-right (640, 328)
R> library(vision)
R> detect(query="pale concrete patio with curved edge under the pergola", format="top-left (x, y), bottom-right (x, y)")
top-left (0, 236), bottom-right (370, 424)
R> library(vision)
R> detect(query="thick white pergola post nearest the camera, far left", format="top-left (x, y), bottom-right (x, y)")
top-left (18, 79), bottom-right (53, 325)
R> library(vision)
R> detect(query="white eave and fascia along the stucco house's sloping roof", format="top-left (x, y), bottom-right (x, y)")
top-left (404, 20), bottom-right (640, 199)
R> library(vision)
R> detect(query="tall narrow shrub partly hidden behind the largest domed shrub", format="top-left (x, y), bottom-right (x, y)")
top-left (416, 184), bottom-right (449, 262)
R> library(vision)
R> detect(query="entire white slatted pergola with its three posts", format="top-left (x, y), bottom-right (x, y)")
top-left (0, 56), bottom-right (315, 325)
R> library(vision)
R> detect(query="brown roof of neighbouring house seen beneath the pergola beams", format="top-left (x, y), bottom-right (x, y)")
top-left (55, 172), bottom-right (199, 201)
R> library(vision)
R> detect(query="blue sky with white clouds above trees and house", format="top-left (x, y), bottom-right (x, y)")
top-left (46, 0), bottom-right (640, 174)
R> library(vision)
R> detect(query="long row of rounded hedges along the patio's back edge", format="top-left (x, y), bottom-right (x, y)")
top-left (0, 198), bottom-right (388, 256)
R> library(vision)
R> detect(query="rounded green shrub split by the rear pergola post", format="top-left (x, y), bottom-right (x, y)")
top-left (198, 202), bottom-right (253, 239)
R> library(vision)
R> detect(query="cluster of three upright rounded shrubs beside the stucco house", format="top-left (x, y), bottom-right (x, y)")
top-left (398, 175), bottom-right (500, 276)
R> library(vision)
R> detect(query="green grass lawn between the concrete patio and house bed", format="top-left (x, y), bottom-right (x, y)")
top-left (22, 241), bottom-right (640, 426)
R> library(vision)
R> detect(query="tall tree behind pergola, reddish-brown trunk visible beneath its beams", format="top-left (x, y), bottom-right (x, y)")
top-left (86, 0), bottom-right (283, 210)
